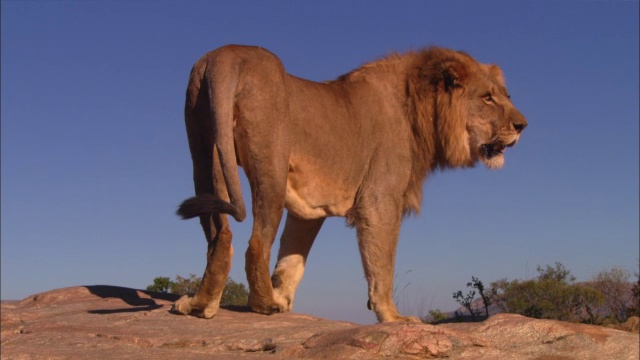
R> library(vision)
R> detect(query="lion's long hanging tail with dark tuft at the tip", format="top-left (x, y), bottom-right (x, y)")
top-left (176, 51), bottom-right (247, 221)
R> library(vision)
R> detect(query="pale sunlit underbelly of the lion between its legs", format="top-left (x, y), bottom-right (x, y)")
top-left (285, 167), bottom-right (355, 219)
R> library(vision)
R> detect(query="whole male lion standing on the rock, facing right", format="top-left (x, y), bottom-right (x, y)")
top-left (174, 45), bottom-right (527, 322)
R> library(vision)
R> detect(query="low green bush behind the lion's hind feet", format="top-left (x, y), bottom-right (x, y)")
top-left (147, 274), bottom-right (249, 306)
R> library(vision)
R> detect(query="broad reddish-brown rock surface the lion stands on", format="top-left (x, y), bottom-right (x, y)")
top-left (1, 286), bottom-right (639, 360)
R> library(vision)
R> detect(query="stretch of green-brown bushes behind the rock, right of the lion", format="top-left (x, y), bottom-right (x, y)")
top-left (444, 262), bottom-right (640, 325)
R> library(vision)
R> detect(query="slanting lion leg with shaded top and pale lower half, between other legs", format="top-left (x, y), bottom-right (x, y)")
top-left (271, 213), bottom-right (324, 311)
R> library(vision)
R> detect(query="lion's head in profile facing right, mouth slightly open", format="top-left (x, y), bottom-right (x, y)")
top-left (417, 48), bottom-right (527, 169)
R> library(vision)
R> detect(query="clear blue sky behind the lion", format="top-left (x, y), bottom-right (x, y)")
top-left (1, 0), bottom-right (639, 323)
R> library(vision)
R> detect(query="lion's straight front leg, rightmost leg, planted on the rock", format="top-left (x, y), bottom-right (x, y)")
top-left (355, 200), bottom-right (420, 322)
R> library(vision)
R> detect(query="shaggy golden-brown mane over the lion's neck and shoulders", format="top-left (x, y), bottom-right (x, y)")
top-left (327, 47), bottom-right (482, 215)
